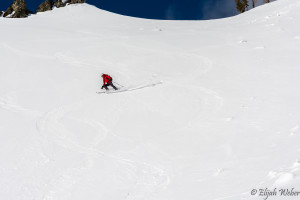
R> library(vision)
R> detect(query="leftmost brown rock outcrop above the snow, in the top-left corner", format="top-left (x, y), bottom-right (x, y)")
top-left (3, 0), bottom-right (31, 18)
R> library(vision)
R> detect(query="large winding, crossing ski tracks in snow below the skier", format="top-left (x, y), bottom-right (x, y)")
top-left (36, 97), bottom-right (170, 199)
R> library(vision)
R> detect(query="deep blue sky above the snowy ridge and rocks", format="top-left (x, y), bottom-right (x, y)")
top-left (0, 0), bottom-right (236, 20)
